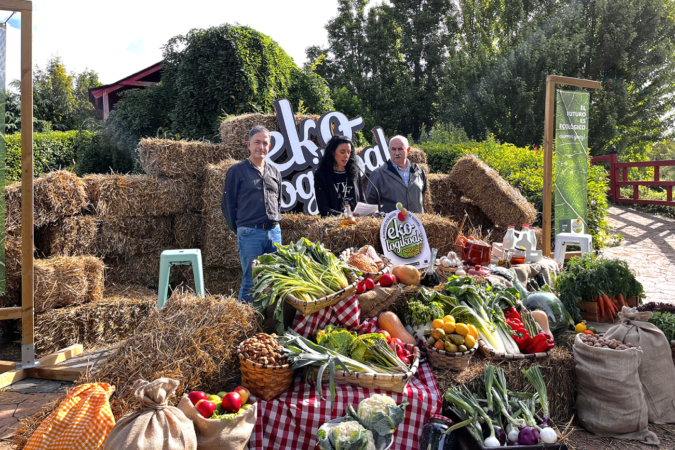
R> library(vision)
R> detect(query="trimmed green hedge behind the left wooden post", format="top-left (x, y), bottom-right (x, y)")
top-left (5, 131), bottom-right (93, 183)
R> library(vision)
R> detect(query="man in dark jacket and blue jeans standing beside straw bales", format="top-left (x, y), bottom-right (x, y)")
top-left (220, 126), bottom-right (281, 303)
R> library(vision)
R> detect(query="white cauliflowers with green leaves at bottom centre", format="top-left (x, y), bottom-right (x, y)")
top-left (317, 394), bottom-right (409, 450)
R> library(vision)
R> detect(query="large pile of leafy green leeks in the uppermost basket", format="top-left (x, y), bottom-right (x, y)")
top-left (253, 238), bottom-right (360, 334)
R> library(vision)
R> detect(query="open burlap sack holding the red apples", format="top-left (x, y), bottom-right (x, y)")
top-left (178, 395), bottom-right (258, 450)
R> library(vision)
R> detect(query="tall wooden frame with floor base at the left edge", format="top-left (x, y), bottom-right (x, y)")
top-left (0, 0), bottom-right (82, 388)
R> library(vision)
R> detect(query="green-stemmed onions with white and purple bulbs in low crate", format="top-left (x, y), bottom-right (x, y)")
top-left (445, 366), bottom-right (558, 448)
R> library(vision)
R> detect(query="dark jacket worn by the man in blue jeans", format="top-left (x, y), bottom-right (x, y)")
top-left (220, 159), bottom-right (282, 233)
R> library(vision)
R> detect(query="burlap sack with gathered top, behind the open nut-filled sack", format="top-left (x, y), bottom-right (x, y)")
top-left (605, 306), bottom-right (675, 423)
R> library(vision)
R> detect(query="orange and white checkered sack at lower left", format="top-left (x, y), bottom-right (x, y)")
top-left (24, 383), bottom-right (115, 450)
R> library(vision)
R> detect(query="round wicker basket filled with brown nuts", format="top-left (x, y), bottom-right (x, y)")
top-left (238, 333), bottom-right (293, 401)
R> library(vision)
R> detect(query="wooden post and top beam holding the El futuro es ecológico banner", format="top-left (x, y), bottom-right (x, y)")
top-left (542, 75), bottom-right (602, 256)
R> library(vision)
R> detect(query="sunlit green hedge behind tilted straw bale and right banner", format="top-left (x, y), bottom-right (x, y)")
top-left (417, 138), bottom-right (611, 248)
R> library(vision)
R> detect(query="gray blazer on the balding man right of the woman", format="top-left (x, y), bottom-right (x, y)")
top-left (366, 161), bottom-right (427, 214)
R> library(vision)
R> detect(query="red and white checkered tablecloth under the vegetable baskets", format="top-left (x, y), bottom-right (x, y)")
top-left (249, 297), bottom-right (443, 450)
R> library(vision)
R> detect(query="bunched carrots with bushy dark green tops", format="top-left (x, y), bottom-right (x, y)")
top-left (555, 253), bottom-right (645, 323)
